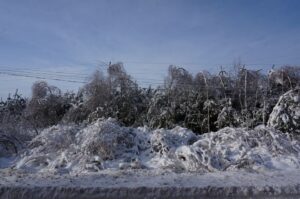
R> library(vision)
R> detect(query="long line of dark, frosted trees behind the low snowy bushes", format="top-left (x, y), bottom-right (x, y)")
top-left (0, 63), bottom-right (300, 137)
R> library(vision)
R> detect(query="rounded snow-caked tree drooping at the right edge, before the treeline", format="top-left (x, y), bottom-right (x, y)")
top-left (268, 88), bottom-right (300, 134)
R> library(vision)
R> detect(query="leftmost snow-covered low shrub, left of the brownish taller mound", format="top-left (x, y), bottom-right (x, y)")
top-left (16, 125), bottom-right (83, 171)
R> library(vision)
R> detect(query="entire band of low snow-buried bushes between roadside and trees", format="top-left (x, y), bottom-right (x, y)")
top-left (15, 119), bottom-right (300, 174)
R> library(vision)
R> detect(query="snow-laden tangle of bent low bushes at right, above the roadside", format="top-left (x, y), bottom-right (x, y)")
top-left (176, 127), bottom-right (300, 171)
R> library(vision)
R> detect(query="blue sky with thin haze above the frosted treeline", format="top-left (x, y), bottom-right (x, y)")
top-left (0, 0), bottom-right (300, 97)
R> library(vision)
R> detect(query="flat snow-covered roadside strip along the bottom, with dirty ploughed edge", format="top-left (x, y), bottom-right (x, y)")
top-left (0, 169), bottom-right (300, 199)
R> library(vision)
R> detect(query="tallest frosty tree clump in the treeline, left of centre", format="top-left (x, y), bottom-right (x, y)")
top-left (74, 63), bottom-right (151, 126)
